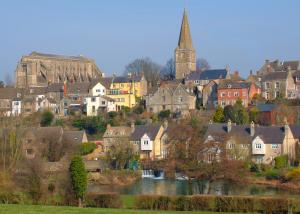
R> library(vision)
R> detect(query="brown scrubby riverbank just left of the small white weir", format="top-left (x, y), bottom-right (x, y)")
top-left (88, 170), bottom-right (141, 186)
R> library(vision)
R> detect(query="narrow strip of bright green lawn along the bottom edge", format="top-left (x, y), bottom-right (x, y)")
top-left (0, 204), bottom-right (220, 214)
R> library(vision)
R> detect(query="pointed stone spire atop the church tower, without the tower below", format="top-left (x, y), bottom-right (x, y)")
top-left (178, 9), bottom-right (193, 49)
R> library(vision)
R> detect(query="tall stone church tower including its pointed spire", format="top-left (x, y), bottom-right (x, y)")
top-left (175, 10), bottom-right (196, 79)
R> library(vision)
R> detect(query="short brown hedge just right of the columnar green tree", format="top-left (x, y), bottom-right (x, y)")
top-left (86, 193), bottom-right (123, 208)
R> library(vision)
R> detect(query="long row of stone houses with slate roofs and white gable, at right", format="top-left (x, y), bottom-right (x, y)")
top-left (206, 121), bottom-right (299, 164)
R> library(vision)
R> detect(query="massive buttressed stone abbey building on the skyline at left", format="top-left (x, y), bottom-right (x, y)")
top-left (16, 52), bottom-right (103, 88)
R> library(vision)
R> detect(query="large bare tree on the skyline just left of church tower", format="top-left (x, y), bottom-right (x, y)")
top-left (125, 58), bottom-right (161, 86)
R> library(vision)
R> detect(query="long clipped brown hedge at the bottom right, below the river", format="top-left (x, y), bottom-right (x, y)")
top-left (135, 195), bottom-right (300, 214)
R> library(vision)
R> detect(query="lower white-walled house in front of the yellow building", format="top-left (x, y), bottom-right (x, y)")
top-left (86, 96), bottom-right (116, 116)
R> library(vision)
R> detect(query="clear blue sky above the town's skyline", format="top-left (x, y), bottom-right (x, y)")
top-left (0, 0), bottom-right (300, 80)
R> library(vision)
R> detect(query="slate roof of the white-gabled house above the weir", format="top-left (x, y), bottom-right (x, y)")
top-left (130, 124), bottom-right (161, 141)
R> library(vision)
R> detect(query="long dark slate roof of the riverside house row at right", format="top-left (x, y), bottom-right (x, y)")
top-left (206, 124), bottom-right (284, 144)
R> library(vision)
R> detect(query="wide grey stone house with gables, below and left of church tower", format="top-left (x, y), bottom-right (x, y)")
top-left (146, 82), bottom-right (196, 114)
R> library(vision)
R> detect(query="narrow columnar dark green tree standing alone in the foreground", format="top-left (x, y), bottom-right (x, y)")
top-left (70, 155), bottom-right (87, 207)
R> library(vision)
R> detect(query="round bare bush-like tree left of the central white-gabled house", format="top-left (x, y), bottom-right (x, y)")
top-left (107, 138), bottom-right (135, 169)
